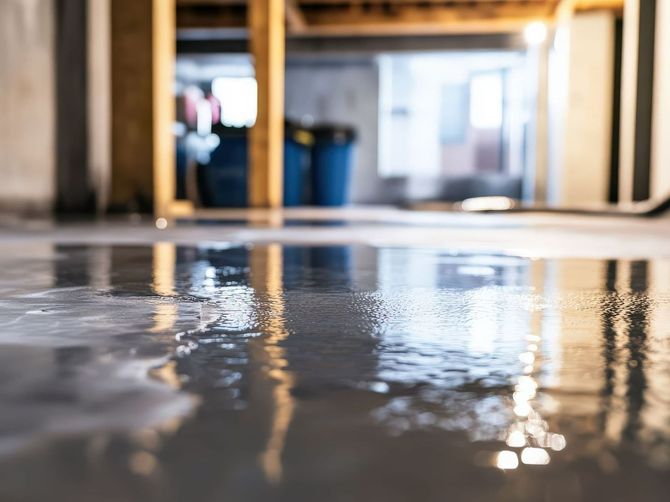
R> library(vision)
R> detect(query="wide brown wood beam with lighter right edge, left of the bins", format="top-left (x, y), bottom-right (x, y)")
top-left (110, 0), bottom-right (176, 214)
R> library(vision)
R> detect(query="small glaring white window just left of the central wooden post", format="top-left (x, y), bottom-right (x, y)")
top-left (212, 77), bottom-right (258, 127)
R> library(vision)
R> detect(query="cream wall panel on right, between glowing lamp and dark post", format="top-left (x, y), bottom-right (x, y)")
top-left (551, 11), bottom-right (614, 206)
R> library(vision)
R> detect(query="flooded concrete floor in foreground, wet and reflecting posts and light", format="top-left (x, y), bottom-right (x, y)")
top-left (0, 218), bottom-right (670, 502)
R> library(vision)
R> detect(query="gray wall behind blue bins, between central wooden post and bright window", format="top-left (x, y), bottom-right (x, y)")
top-left (286, 58), bottom-right (402, 204)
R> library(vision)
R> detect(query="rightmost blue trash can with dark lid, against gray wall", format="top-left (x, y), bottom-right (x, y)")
top-left (312, 125), bottom-right (356, 206)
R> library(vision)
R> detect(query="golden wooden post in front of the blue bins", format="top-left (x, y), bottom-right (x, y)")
top-left (248, 0), bottom-right (285, 208)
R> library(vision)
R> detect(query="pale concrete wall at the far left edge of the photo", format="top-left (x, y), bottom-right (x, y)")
top-left (0, 0), bottom-right (55, 211)
